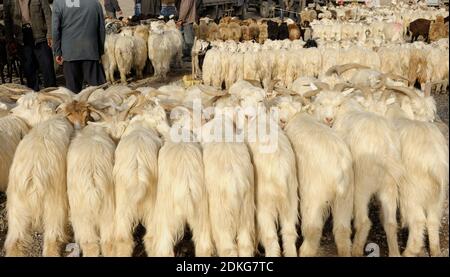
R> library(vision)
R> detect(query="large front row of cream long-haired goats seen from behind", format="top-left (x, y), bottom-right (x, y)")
top-left (0, 57), bottom-right (449, 256)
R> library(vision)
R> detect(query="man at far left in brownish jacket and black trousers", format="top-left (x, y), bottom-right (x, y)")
top-left (3, 0), bottom-right (56, 91)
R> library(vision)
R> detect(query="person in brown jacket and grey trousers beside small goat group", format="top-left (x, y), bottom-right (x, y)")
top-left (177, 0), bottom-right (197, 61)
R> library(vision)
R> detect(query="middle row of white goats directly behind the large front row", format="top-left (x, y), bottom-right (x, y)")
top-left (198, 38), bottom-right (449, 91)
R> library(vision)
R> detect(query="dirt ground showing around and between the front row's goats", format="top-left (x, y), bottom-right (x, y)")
top-left (0, 59), bottom-right (449, 257)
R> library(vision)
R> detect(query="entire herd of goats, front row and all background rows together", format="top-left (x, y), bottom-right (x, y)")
top-left (0, 1), bottom-right (449, 257)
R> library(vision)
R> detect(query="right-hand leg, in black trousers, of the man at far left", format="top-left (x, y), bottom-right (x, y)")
top-left (34, 42), bottom-right (56, 88)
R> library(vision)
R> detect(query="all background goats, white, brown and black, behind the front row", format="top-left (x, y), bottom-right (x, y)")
top-left (102, 1), bottom-right (449, 90)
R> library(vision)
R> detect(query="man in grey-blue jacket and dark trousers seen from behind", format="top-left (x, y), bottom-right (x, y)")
top-left (53, 0), bottom-right (106, 93)
